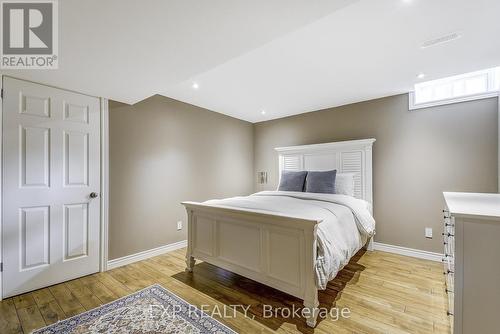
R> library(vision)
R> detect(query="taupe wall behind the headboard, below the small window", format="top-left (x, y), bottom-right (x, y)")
top-left (254, 94), bottom-right (498, 252)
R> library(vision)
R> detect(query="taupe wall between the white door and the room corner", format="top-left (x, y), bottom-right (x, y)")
top-left (109, 96), bottom-right (255, 259)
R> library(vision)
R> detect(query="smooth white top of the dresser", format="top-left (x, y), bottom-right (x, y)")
top-left (443, 192), bottom-right (500, 220)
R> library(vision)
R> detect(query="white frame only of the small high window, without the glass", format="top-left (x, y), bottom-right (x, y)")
top-left (408, 67), bottom-right (500, 110)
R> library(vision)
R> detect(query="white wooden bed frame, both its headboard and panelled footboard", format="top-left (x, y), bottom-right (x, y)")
top-left (182, 139), bottom-right (375, 327)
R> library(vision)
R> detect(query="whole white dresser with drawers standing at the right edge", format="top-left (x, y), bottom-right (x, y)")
top-left (443, 192), bottom-right (500, 334)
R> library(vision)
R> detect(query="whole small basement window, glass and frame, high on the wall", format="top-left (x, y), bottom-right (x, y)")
top-left (409, 67), bottom-right (500, 110)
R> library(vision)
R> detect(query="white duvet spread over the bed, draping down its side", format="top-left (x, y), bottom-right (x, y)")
top-left (205, 191), bottom-right (375, 290)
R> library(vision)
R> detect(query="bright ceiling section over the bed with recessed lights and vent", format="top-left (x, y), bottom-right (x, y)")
top-left (163, 0), bottom-right (500, 122)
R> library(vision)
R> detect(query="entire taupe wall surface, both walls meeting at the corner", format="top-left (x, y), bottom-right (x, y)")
top-left (109, 94), bottom-right (499, 259)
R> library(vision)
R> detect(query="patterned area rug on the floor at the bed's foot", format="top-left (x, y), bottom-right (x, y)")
top-left (33, 285), bottom-right (236, 334)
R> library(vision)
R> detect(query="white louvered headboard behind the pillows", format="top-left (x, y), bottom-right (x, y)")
top-left (275, 138), bottom-right (375, 203)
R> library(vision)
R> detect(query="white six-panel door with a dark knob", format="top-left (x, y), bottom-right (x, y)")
top-left (2, 77), bottom-right (101, 297)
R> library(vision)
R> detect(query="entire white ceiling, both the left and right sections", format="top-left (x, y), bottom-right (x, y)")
top-left (0, 0), bottom-right (500, 122)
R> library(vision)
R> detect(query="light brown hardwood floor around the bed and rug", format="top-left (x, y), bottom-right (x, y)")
top-left (0, 250), bottom-right (450, 334)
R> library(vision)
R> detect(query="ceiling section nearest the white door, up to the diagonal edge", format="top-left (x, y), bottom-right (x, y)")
top-left (2, 0), bottom-right (354, 104)
